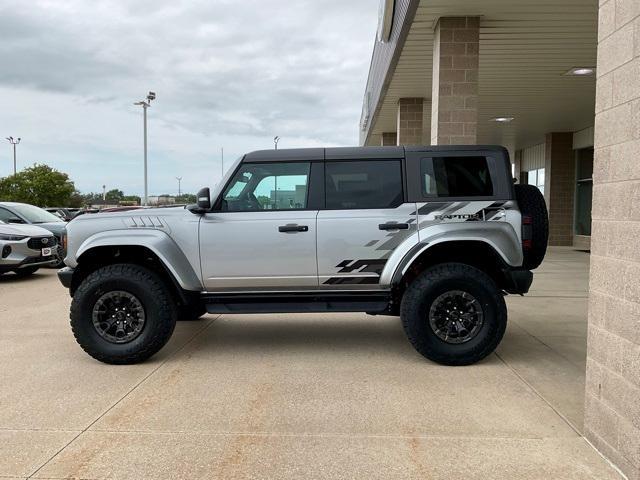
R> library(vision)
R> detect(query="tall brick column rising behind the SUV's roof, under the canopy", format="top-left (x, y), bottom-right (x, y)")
top-left (431, 17), bottom-right (480, 145)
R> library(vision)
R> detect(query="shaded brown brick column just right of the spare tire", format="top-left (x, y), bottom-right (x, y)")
top-left (544, 132), bottom-right (576, 246)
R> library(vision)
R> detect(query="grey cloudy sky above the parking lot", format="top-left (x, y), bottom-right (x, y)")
top-left (0, 0), bottom-right (378, 194)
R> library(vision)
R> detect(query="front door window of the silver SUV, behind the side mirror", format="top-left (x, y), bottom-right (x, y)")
top-left (222, 162), bottom-right (311, 212)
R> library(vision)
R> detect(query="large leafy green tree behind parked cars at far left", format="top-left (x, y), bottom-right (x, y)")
top-left (0, 163), bottom-right (76, 207)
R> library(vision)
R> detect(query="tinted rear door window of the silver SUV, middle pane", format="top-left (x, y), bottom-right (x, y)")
top-left (325, 160), bottom-right (403, 210)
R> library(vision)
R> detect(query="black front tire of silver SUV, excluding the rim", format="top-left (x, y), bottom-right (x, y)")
top-left (70, 263), bottom-right (177, 364)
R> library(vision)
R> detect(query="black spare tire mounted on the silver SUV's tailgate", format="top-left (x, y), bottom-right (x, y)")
top-left (515, 185), bottom-right (549, 270)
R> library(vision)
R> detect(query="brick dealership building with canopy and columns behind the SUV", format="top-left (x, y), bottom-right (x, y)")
top-left (360, 0), bottom-right (640, 478)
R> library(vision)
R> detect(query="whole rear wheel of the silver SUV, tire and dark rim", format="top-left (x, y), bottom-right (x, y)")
top-left (400, 263), bottom-right (507, 365)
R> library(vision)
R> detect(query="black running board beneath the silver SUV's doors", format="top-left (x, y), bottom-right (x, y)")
top-left (203, 291), bottom-right (391, 313)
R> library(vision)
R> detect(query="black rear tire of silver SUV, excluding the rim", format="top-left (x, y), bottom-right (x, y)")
top-left (400, 263), bottom-right (507, 365)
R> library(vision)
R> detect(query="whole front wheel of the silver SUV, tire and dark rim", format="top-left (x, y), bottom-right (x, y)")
top-left (70, 264), bottom-right (177, 364)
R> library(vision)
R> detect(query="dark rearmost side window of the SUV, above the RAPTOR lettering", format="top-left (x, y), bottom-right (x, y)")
top-left (420, 156), bottom-right (493, 197)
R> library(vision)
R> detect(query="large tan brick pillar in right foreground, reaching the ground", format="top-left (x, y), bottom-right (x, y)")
top-left (585, 0), bottom-right (640, 480)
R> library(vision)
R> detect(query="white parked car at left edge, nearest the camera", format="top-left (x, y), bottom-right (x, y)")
top-left (0, 221), bottom-right (58, 277)
